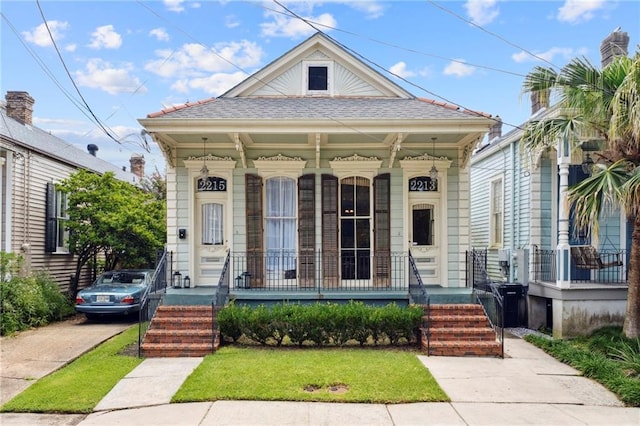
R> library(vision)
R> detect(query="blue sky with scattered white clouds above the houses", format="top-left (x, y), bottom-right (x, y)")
top-left (0, 0), bottom-right (640, 173)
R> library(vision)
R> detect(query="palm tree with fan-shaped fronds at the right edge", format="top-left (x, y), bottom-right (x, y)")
top-left (522, 51), bottom-right (640, 338)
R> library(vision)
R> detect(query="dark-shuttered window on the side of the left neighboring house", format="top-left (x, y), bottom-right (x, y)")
top-left (45, 182), bottom-right (69, 253)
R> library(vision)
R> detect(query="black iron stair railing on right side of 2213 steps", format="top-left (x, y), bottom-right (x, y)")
top-left (467, 250), bottom-right (504, 358)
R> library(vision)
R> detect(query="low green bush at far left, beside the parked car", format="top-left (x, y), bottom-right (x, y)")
top-left (0, 274), bottom-right (74, 336)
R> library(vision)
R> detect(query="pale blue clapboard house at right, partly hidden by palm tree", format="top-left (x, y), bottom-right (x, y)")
top-left (471, 32), bottom-right (632, 337)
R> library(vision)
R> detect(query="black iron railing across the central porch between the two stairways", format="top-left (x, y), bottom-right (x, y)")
top-left (230, 251), bottom-right (408, 292)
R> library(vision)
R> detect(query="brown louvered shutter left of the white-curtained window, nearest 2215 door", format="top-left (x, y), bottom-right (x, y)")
top-left (245, 174), bottom-right (264, 287)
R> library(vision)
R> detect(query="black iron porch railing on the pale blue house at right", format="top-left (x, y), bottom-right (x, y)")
top-left (532, 247), bottom-right (629, 284)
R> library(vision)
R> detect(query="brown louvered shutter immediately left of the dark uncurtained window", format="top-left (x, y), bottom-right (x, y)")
top-left (322, 175), bottom-right (340, 287)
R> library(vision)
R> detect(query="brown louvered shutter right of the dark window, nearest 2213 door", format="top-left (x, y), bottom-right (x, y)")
top-left (373, 173), bottom-right (391, 286)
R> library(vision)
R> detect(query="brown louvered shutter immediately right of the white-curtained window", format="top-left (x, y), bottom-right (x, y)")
top-left (298, 174), bottom-right (316, 287)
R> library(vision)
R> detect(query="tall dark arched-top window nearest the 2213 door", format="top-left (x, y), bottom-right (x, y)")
top-left (340, 177), bottom-right (371, 280)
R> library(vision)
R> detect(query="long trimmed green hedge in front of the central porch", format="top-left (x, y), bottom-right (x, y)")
top-left (218, 301), bottom-right (423, 347)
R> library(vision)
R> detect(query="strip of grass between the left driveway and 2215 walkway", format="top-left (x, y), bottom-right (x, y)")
top-left (0, 325), bottom-right (142, 413)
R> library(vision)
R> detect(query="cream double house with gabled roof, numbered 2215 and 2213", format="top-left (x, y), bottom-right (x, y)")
top-left (139, 33), bottom-right (493, 297)
